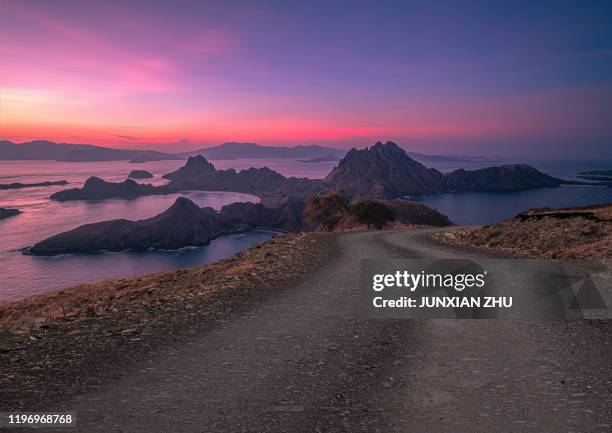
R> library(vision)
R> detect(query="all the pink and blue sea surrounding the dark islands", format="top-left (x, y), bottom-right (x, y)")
top-left (0, 159), bottom-right (612, 302)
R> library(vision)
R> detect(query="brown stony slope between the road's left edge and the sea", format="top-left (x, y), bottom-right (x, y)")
top-left (0, 234), bottom-right (334, 410)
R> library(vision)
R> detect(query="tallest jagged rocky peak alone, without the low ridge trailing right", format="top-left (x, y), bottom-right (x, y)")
top-left (324, 141), bottom-right (445, 199)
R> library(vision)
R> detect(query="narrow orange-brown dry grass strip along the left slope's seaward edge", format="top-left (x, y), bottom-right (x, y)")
top-left (0, 235), bottom-right (320, 330)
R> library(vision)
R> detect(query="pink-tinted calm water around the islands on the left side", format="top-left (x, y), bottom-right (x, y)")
top-left (0, 161), bottom-right (273, 301)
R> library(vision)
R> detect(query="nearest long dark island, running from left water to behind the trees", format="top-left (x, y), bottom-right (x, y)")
top-left (23, 197), bottom-right (452, 255)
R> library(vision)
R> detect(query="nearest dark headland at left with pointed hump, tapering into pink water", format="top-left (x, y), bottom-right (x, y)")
top-left (25, 197), bottom-right (227, 255)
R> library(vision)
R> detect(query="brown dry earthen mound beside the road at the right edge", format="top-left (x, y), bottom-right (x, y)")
top-left (435, 204), bottom-right (612, 259)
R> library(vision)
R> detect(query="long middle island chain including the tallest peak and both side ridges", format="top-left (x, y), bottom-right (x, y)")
top-left (46, 142), bottom-right (577, 206)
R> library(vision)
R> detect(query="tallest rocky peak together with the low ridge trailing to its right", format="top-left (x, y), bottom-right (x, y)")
top-left (324, 142), bottom-right (572, 199)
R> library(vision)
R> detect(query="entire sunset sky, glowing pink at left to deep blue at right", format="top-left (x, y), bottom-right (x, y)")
top-left (0, 0), bottom-right (612, 159)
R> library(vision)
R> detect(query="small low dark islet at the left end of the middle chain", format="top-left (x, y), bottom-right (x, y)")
top-left (50, 177), bottom-right (160, 201)
